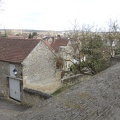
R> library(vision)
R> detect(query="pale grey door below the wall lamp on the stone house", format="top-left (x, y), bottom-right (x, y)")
top-left (9, 78), bottom-right (20, 101)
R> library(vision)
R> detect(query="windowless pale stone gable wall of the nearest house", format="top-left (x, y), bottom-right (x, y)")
top-left (22, 41), bottom-right (61, 94)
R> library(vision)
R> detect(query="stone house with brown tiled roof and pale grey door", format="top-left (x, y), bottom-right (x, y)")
top-left (0, 38), bottom-right (61, 101)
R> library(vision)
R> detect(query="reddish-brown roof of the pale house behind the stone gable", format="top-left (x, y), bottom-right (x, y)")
top-left (51, 37), bottom-right (69, 52)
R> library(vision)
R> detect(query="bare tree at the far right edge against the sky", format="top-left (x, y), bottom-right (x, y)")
top-left (103, 20), bottom-right (120, 57)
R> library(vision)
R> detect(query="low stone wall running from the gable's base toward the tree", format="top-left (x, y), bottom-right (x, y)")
top-left (61, 74), bottom-right (92, 85)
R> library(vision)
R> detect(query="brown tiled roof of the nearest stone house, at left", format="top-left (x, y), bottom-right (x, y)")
top-left (0, 38), bottom-right (40, 63)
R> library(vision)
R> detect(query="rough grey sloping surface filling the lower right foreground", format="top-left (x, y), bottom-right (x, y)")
top-left (11, 64), bottom-right (120, 120)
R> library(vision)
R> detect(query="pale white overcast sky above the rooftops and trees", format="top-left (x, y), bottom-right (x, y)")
top-left (0, 0), bottom-right (120, 30)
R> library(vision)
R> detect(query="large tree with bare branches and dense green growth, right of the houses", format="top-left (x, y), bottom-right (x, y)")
top-left (62, 23), bottom-right (109, 74)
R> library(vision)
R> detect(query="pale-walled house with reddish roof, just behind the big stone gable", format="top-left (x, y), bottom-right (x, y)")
top-left (51, 36), bottom-right (73, 71)
